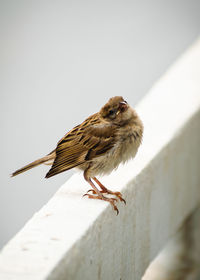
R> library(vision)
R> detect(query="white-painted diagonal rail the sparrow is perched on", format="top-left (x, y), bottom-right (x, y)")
top-left (0, 38), bottom-right (200, 280)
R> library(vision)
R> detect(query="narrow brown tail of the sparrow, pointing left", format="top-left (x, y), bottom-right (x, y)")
top-left (11, 151), bottom-right (56, 177)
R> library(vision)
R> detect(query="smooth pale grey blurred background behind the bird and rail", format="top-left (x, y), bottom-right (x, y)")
top-left (0, 0), bottom-right (200, 247)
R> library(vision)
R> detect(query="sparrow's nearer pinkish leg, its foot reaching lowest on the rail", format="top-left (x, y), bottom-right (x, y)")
top-left (83, 172), bottom-right (119, 215)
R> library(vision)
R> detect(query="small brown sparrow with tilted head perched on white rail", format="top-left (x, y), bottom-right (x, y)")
top-left (12, 96), bottom-right (143, 214)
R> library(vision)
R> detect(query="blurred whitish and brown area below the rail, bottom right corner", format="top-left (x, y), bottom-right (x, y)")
top-left (142, 207), bottom-right (200, 280)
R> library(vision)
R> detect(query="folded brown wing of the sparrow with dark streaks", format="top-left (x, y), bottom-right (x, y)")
top-left (46, 114), bottom-right (116, 178)
